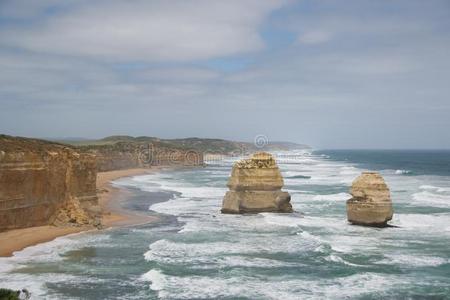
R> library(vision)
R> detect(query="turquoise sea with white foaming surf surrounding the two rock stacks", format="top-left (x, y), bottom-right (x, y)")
top-left (0, 151), bottom-right (450, 299)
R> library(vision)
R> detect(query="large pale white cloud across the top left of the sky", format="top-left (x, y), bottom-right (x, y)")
top-left (0, 0), bottom-right (284, 62)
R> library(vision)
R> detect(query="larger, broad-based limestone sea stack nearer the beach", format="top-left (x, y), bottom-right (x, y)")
top-left (222, 152), bottom-right (292, 214)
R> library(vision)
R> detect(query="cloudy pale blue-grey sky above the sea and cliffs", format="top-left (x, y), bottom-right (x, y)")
top-left (0, 0), bottom-right (450, 149)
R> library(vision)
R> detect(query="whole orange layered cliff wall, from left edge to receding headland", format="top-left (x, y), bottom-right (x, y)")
top-left (0, 135), bottom-right (203, 232)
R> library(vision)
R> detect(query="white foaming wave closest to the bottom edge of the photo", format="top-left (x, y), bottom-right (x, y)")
top-left (141, 269), bottom-right (408, 300)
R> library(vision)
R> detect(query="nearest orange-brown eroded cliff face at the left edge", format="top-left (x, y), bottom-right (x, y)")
top-left (0, 136), bottom-right (100, 231)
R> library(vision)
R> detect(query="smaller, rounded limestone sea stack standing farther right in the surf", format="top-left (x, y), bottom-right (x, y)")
top-left (347, 172), bottom-right (393, 227)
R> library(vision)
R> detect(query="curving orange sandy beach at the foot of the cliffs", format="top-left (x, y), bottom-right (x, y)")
top-left (0, 167), bottom-right (158, 257)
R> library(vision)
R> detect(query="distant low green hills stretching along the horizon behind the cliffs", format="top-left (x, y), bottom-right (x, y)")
top-left (57, 135), bottom-right (310, 154)
